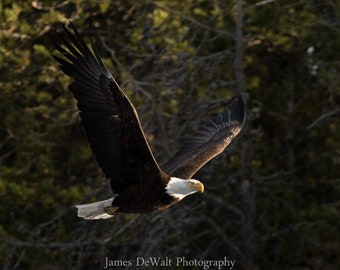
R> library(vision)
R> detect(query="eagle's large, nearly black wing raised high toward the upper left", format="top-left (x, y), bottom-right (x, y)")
top-left (53, 23), bottom-right (164, 194)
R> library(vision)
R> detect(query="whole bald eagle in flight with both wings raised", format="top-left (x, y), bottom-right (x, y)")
top-left (53, 23), bottom-right (245, 219)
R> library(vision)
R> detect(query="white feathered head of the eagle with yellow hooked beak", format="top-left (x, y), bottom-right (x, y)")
top-left (165, 177), bottom-right (204, 200)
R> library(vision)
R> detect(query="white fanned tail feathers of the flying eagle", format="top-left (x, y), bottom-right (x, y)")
top-left (76, 198), bottom-right (113, 219)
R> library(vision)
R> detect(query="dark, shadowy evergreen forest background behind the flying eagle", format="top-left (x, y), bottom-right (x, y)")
top-left (0, 0), bottom-right (340, 270)
